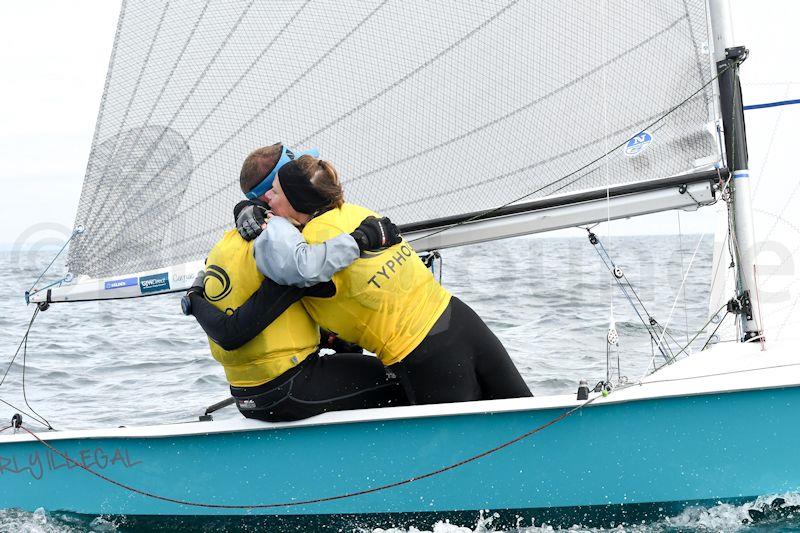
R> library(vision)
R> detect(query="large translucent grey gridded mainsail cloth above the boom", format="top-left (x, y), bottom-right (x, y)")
top-left (68, 0), bottom-right (721, 278)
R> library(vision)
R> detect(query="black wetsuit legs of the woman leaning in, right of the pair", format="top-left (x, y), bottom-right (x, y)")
top-left (389, 297), bottom-right (532, 404)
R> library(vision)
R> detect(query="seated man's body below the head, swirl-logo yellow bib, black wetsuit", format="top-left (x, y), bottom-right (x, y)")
top-left (188, 143), bottom-right (407, 421)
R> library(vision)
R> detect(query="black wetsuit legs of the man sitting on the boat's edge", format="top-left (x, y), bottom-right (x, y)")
top-left (231, 353), bottom-right (408, 422)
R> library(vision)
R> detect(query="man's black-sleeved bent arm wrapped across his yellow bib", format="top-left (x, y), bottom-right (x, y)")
top-left (189, 278), bottom-right (307, 350)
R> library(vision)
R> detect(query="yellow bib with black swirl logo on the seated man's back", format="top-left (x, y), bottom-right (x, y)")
top-left (205, 229), bottom-right (319, 387)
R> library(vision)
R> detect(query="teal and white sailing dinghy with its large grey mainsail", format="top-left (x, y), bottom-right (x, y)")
top-left (0, 0), bottom-right (800, 523)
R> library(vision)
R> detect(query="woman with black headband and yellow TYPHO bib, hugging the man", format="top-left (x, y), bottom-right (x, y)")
top-left (228, 155), bottom-right (531, 404)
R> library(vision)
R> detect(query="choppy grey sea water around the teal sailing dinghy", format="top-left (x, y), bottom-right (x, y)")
top-left (0, 235), bottom-right (800, 533)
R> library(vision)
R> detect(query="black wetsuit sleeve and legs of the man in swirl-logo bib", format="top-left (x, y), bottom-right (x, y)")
top-left (191, 278), bottom-right (408, 422)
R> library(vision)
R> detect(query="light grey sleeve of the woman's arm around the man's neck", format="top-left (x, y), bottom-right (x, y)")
top-left (253, 217), bottom-right (360, 287)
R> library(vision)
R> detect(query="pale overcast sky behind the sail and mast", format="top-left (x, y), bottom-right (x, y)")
top-left (0, 0), bottom-right (800, 249)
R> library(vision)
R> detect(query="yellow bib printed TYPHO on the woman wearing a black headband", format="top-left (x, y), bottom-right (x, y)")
top-left (303, 204), bottom-right (450, 365)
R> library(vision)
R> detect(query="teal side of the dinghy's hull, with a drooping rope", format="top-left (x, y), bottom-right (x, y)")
top-left (0, 387), bottom-right (800, 523)
